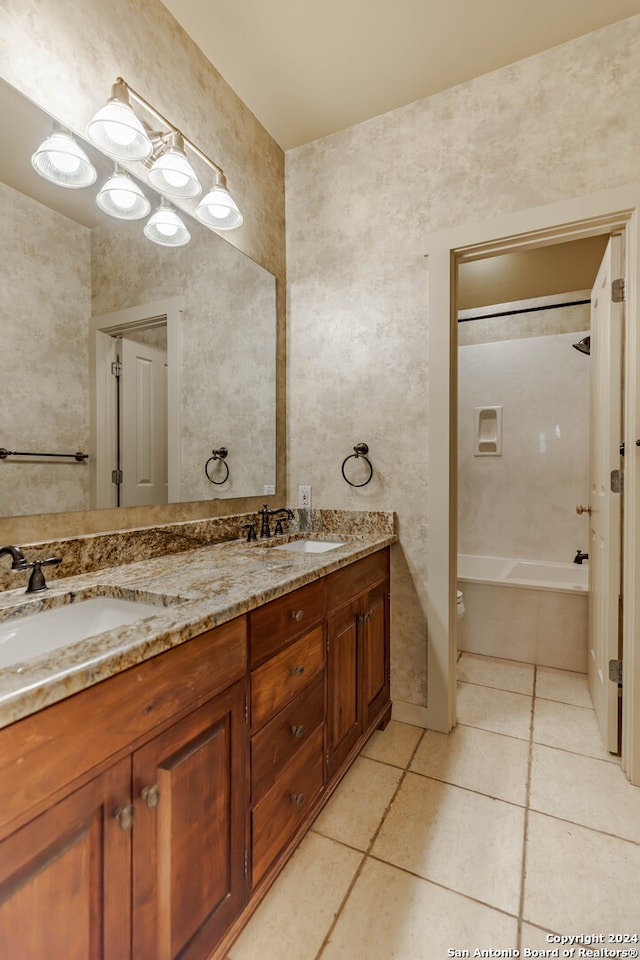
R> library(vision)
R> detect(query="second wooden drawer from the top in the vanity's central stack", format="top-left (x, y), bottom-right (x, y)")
top-left (251, 624), bottom-right (324, 730)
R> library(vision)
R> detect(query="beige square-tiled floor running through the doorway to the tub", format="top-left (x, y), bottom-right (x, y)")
top-left (229, 653), bottom-right (640, 960)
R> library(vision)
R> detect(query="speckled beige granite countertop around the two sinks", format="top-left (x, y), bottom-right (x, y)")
top-left (0, 531), bottom-right (397, 727)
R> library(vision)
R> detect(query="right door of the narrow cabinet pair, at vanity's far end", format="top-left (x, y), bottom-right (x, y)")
top-left (362, 583), bottom-right (390, 730)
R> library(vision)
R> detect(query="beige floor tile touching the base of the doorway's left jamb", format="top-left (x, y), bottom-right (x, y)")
top-left (410, 726), bottom-right (529, 805)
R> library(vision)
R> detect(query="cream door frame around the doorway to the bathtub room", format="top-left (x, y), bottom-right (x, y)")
top-left (425, 183), bottom-right (640, 785)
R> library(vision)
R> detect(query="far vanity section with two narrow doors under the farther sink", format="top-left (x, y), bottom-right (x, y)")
top-left (326, 550), bottom-right (391, 779)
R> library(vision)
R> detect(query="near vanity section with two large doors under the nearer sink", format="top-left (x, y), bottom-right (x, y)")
top-left (0, 618), bottom-right (248, 960)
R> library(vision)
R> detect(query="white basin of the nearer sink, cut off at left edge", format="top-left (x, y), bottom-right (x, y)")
top-left (0, 597), bottom-right (164, 669)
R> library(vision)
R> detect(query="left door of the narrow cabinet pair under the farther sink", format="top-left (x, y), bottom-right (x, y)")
top-left (327, 602), bottom-right (362, 777)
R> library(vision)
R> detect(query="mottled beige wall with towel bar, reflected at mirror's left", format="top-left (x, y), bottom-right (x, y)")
top-left (0, 183), bottom-right (91, 517)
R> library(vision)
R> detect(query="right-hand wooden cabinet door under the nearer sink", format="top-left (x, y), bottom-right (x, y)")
top-left (133, 681), bottom-right (248, 960)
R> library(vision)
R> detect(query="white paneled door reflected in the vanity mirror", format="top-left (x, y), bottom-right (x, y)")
top-left (120, 337), bottom-right (168, 507)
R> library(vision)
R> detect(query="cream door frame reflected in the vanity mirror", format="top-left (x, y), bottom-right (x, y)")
top-left (89, 297), bottom-right (184, 507)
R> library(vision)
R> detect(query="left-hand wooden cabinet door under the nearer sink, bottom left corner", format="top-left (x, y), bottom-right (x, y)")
top-left (0, 759), bottom-right (131, 960)
